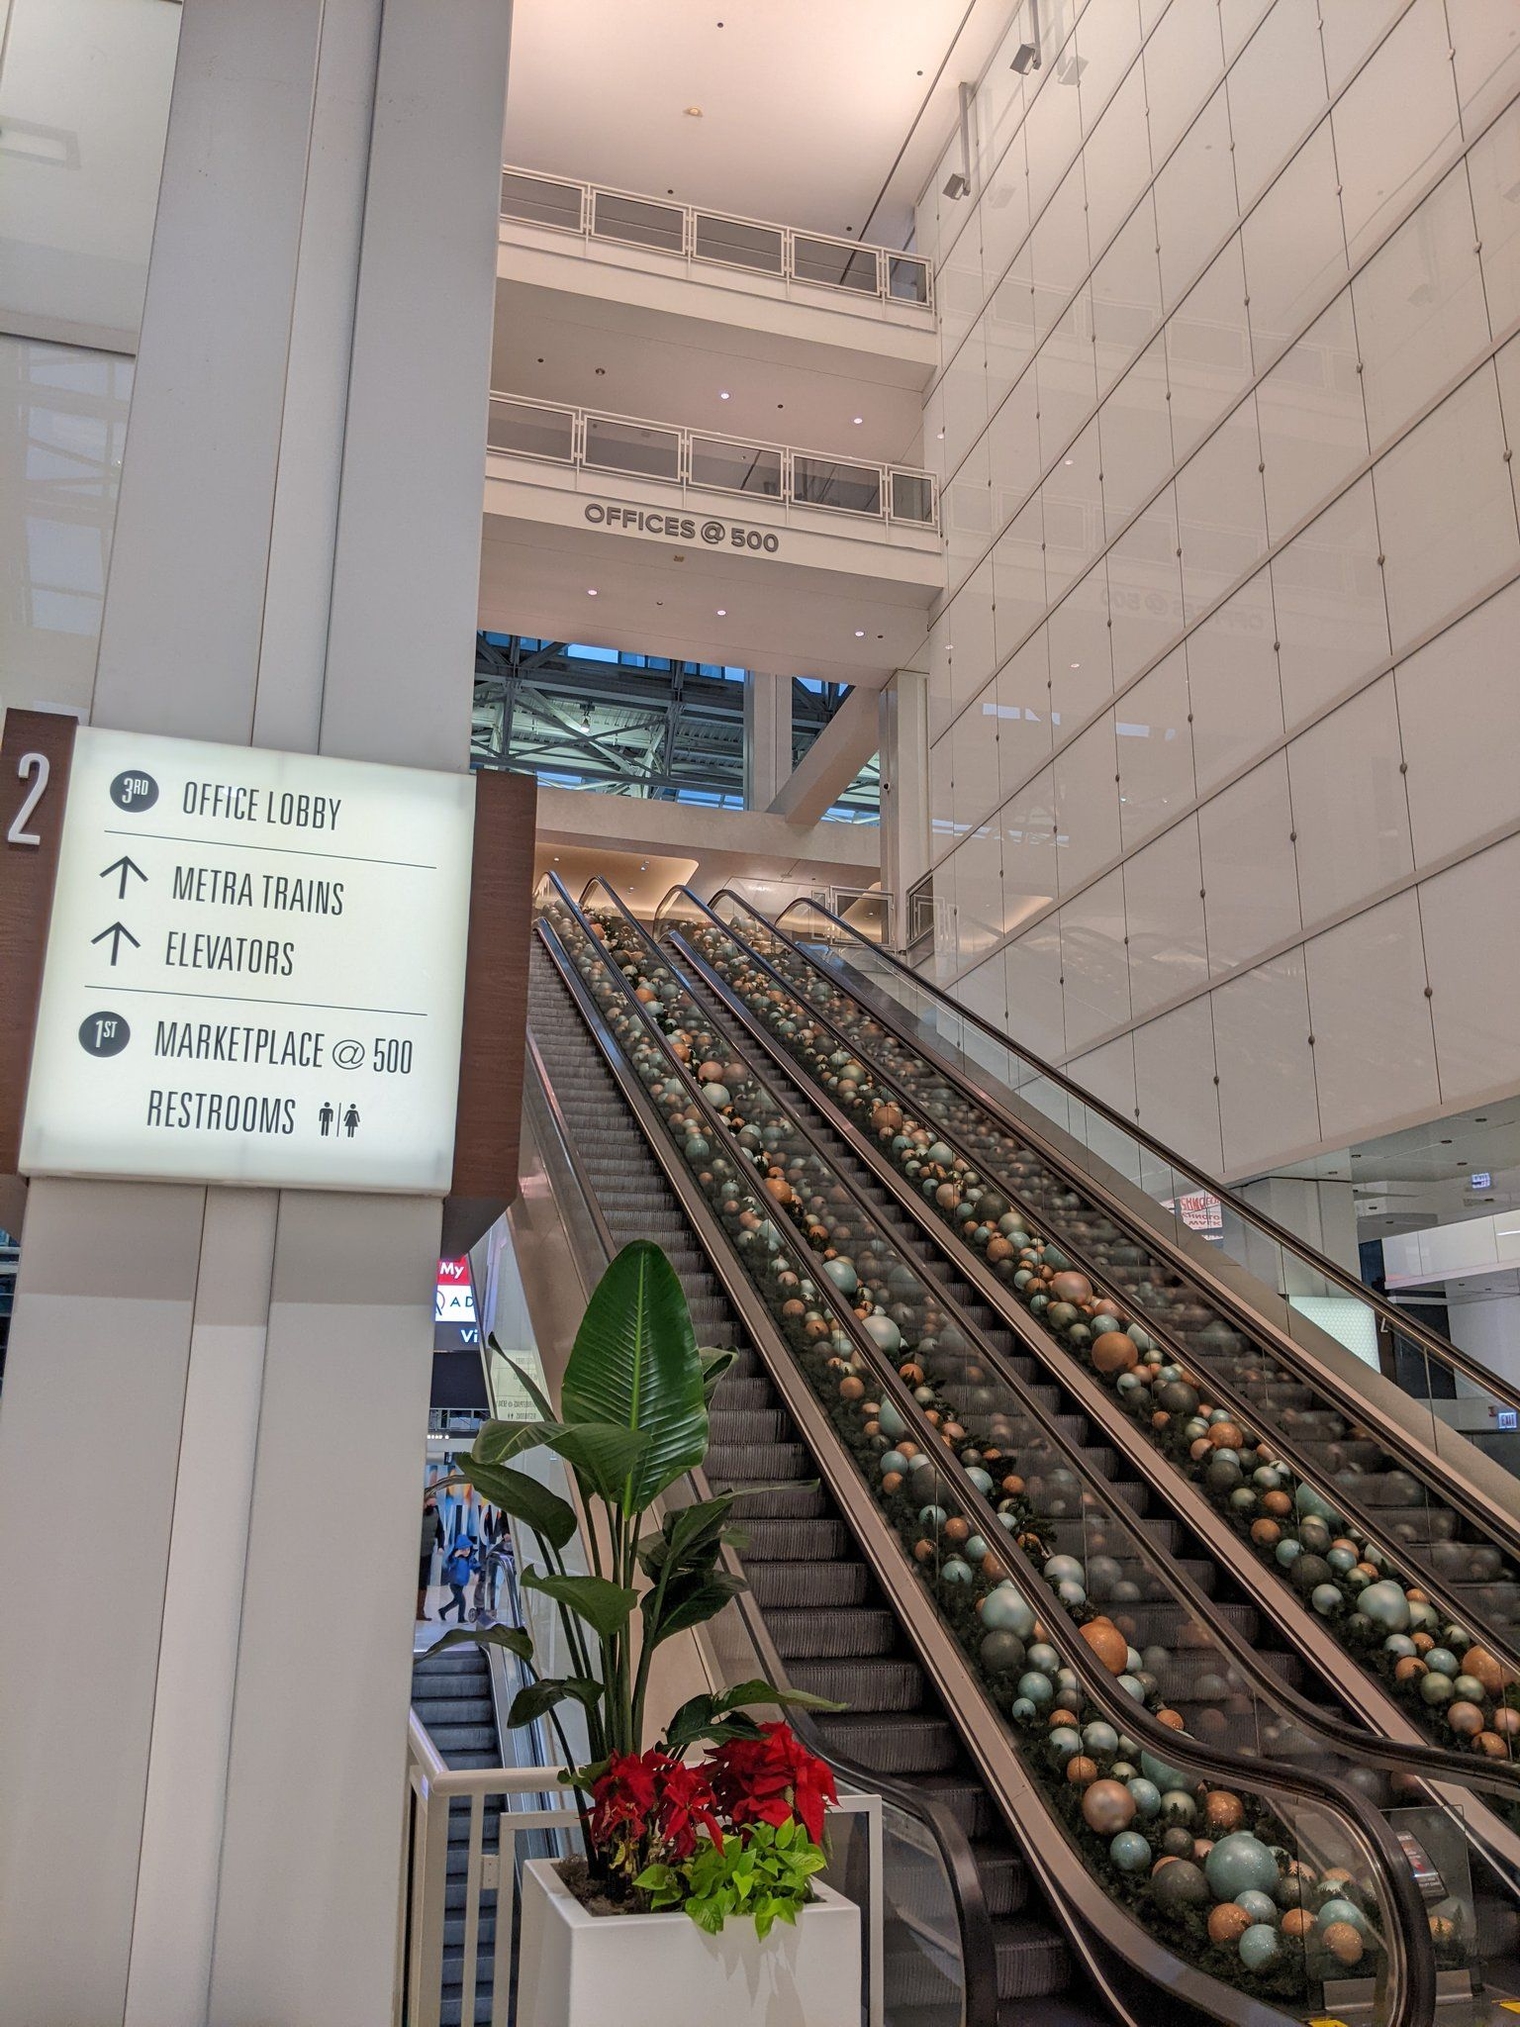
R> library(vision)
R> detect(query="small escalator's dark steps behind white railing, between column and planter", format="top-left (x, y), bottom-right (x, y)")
top-left (411, 1646), bottom-right (503, 2027)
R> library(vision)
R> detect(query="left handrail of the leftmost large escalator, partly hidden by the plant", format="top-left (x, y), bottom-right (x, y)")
top-left (513, 948), bottom-right (1013, 2027)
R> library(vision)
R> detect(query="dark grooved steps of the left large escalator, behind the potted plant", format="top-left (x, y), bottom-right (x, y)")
top-left (529, 943), bottom-right (1107, 2027)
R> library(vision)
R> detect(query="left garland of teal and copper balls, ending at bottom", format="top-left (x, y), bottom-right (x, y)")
top-left (543, 918), bottom-right (1442, 2003)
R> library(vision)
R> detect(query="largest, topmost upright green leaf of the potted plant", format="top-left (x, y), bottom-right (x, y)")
top-left (561, 1238), bottom-right (707, 1512)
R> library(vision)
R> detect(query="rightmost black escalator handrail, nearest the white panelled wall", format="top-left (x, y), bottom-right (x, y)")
top-left (709, 886), bottom-right (1520, 1409)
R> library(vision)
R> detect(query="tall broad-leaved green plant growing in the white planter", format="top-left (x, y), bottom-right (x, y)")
top-left (440, 1241), bottom-right (839, 1928)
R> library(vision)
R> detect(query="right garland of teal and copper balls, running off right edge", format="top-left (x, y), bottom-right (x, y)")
top-left (697, 928), bottom-right (1520, 1775)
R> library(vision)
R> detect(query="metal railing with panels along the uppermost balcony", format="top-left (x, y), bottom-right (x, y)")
top-left (501, 166), bottom-right (934, 312)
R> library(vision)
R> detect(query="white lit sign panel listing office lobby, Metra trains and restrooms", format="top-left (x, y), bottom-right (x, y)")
top-left (20, 728), bottom-right (474, 1196)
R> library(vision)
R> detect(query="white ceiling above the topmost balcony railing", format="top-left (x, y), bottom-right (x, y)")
top-left (505, 0), bottom-right (1013, 245)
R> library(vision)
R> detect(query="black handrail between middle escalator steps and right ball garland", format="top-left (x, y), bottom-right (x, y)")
top-left (671, 932), bottom-right (1520, 1824)
